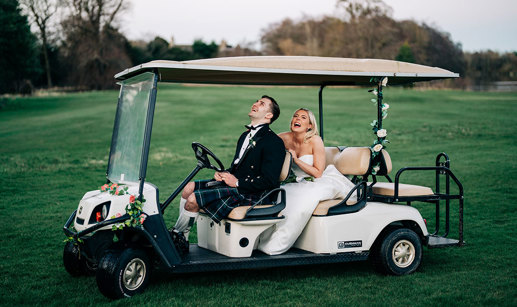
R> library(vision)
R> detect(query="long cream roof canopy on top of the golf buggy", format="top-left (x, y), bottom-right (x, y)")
top-left (115, 56), bottom-right (459, 85)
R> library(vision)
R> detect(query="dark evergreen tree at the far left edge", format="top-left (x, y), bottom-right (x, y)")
top-left (0, 0), bottom-right (40, 93)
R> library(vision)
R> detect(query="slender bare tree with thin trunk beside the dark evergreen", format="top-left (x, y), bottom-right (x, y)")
top-left (21, 0), bottom-right (57, 88)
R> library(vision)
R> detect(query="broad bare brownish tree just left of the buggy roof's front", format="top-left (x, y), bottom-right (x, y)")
top-left (62, 0), bottom-right (131, 89)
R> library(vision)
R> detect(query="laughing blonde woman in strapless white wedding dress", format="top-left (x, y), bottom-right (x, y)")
top-left (258, 108), bottom-right (354, 255)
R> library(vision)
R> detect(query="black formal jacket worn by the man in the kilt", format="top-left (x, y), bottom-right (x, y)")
top-left (229, 125), bottom-right (285, 194)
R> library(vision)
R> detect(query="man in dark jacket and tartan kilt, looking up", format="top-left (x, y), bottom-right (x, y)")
top-left (172, 95), bottom-right (285, 252)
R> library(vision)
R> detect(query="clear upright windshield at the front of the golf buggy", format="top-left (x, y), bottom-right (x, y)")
top-left (108, 73), bottom-right (154, 183)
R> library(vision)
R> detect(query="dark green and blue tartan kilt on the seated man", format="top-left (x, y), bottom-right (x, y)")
top-left (194, 180), bottom-right (269, 223)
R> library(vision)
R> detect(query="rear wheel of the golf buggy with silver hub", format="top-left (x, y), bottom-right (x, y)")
top-left (372, 228), bottom-right (422, 276)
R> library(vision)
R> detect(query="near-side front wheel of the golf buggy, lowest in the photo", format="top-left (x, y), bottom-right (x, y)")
top-left (96, 248), bottom-right (151, 299)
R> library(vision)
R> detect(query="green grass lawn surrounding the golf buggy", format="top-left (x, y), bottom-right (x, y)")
top-left (0, 85), bottom-right (517, 306)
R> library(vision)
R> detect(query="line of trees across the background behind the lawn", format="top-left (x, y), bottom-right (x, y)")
top-left (0, 0), bottom-right (517, 93)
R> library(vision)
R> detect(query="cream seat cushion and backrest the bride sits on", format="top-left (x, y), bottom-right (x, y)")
top-left (312, 147), bottom-right (371, 216)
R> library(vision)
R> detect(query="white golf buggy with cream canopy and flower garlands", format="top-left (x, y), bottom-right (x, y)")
top-left (63, 56), bottom-right (464, 299)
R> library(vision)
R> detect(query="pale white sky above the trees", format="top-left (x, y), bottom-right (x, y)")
top-left (121, 0), bottom-right (517, 52)
